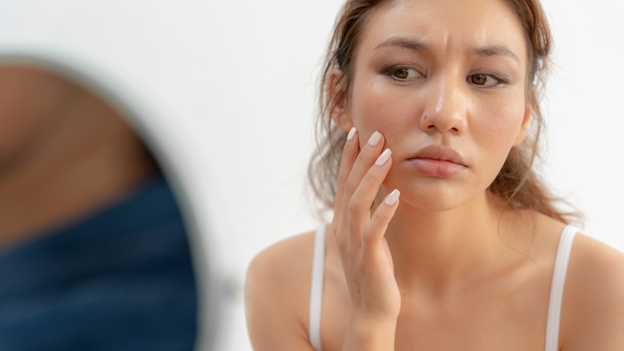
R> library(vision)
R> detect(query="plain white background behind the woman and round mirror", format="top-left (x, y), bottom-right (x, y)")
top-left (0, 0), bottom-right (624, 350)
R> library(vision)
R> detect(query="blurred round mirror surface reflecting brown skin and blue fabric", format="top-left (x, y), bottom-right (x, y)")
top-left (0, 63), bottom-right (198, 351)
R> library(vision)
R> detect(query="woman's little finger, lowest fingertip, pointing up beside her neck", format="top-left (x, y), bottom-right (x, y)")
top-left (362, 189), bottom-right (401, 251)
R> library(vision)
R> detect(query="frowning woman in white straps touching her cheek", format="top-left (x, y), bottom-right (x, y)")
top-left (246, 0), bottom-right (624, 351)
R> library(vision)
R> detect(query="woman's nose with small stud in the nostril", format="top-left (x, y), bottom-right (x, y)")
top-left (420, 74), bottom-right (468, 136)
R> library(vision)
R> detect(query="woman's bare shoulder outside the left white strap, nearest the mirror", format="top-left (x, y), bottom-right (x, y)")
top-left (245, 232), bottom-right (314, 351)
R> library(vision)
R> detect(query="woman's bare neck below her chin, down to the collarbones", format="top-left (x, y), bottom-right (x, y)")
top-left (380, 188), bottom-right (508, 294)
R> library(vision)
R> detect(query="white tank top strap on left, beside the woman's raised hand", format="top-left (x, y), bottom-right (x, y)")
top-left (308, 225), bottom-right (326, 351)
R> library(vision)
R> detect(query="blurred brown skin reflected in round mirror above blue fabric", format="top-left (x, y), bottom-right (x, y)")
top-left (0, 65), bottom-right (155, 247)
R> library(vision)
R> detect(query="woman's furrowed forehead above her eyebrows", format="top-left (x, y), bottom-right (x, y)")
top-left (358, 0), bottom-right (527, 63)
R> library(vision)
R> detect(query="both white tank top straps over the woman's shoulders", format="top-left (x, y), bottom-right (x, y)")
top-left (308, 225), bottom-right (578, 351)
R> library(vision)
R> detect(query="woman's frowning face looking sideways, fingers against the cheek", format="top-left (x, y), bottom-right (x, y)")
top-left (339, 0), bottom-right (532, 210)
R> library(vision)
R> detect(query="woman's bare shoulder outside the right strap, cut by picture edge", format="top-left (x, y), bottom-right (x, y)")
top-left (561, 233), bottom-right (624, 351)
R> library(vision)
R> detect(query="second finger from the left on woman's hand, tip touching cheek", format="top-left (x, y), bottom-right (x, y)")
top-left (342, 131), bottom-right (385, 219)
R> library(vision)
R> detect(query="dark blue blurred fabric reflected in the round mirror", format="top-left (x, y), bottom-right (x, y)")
top-left (0, 176), bottom-right (197, 351)
